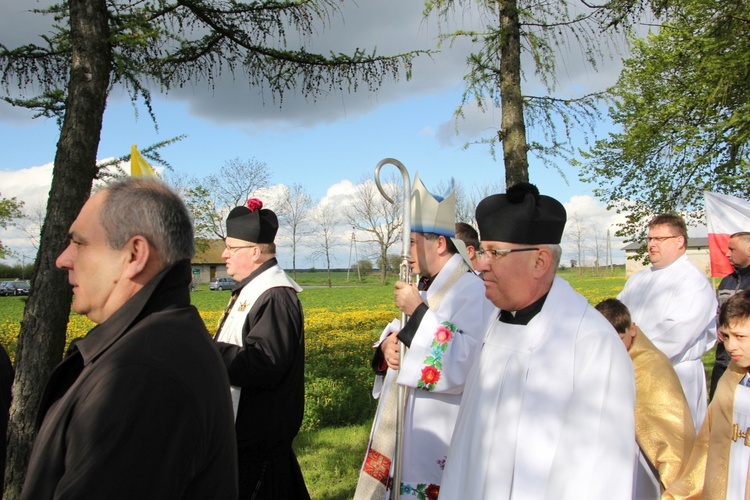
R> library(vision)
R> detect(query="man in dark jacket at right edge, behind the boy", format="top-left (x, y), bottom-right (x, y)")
top-left (709, 231), bottom-right (750, 397)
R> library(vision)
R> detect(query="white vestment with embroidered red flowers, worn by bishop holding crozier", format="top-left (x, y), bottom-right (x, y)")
top-left (366, 255), bottom-right (495, 498)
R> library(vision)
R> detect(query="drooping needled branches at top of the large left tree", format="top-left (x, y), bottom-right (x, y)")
top-left (0, 0), bottom-right (418, 119)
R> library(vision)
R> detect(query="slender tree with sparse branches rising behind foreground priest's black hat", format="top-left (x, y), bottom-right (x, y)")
top-left (425, 0), bottom-right (641, 186)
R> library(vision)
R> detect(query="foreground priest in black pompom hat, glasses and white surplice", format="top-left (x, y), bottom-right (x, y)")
top-left (440, 183), bottom-right (636, 500)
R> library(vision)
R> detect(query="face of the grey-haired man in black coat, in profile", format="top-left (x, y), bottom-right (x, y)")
top-left (55, 190), bottom-right (128, 323)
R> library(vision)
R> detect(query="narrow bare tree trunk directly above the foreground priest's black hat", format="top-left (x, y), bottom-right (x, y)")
top-left (498, 0), bottom-right (529, 187)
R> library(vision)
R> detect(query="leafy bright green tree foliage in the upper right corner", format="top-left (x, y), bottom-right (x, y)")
top-left (581, 0), bottom-right (750, 241)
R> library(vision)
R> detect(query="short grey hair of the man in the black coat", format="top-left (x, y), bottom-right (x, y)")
top-left (99, 177), bottom-right (195, 267)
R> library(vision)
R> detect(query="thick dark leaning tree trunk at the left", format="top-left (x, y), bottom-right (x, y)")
top-left (4, 0), bottom-right (111, 494)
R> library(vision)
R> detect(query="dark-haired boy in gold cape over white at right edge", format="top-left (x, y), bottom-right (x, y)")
top-left (663, 290), bottom-right (750, 499)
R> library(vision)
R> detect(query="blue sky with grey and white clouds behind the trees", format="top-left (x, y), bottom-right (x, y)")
top-left (0, 0), bottom-right (648, 268)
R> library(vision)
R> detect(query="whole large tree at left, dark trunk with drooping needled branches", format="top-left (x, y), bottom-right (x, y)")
top-left (0, 0), bottom-right (424, 499)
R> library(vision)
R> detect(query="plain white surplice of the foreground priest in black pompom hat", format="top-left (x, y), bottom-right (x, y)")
top-left (440, 278), bottom-right (636, 500)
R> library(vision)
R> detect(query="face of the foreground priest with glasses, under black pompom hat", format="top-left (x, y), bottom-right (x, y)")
top-left (476, 241), bottom-right (538, 311)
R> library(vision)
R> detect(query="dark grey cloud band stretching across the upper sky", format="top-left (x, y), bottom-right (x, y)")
top-left (0, 0), bottom-right (636, 131)
